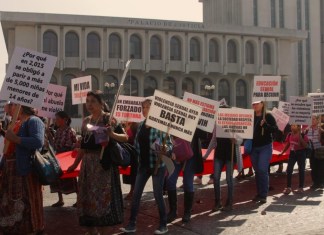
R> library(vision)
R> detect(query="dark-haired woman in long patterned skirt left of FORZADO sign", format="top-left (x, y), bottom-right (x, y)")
top-left (68, 91), bottom-right (128, 235)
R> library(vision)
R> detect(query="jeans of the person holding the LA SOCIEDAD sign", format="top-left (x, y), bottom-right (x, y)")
top-left (214, 158), bottom-right (233, 204)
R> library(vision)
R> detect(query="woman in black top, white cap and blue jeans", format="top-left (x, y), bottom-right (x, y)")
top-left (250, 101), bottom-right (278, 204)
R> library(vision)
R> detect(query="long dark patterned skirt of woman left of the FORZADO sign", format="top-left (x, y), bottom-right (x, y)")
top-left (77, 151), bottom-right (124, 227)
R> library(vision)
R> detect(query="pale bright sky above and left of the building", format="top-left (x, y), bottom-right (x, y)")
top-left (0, 0), bottom-right (202, 85)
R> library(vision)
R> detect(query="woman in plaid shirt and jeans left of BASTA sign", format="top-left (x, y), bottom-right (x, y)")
top-left (120, 98), bottom-right (171, 234)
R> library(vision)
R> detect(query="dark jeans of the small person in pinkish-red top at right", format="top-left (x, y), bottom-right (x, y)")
top-left (287, 149), bottom-right (306, 188)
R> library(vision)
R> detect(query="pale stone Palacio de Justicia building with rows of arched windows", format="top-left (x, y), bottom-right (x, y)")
top-left (0, 0), bottom-right (324, 117)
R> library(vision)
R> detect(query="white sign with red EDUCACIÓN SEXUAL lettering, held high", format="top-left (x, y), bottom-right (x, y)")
top-left (252, 76), bottom-right (281, 102)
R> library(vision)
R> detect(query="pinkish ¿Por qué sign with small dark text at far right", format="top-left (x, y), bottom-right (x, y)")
top-left (289, 96), bottom-right (313, 125)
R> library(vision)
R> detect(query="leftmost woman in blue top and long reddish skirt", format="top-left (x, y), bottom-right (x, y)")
top-left (0, 104), bottom-right (45, 234)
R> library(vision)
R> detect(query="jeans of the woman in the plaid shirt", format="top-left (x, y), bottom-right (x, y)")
top-left (129, 167), bottom-right (167, 226)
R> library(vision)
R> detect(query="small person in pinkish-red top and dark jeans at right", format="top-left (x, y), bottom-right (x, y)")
top-left (279, 124), bottom-right (309, 195)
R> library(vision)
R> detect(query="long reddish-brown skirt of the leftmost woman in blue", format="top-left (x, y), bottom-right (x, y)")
top-left (0, 155), bottom-right (44, 234)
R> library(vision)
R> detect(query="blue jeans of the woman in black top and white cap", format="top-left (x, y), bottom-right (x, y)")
top-left (251, 143), bottom-right (272, 198)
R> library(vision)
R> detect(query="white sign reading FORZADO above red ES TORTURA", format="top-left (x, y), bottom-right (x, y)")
top-left (113, 95), bottom-right (144, 122)
